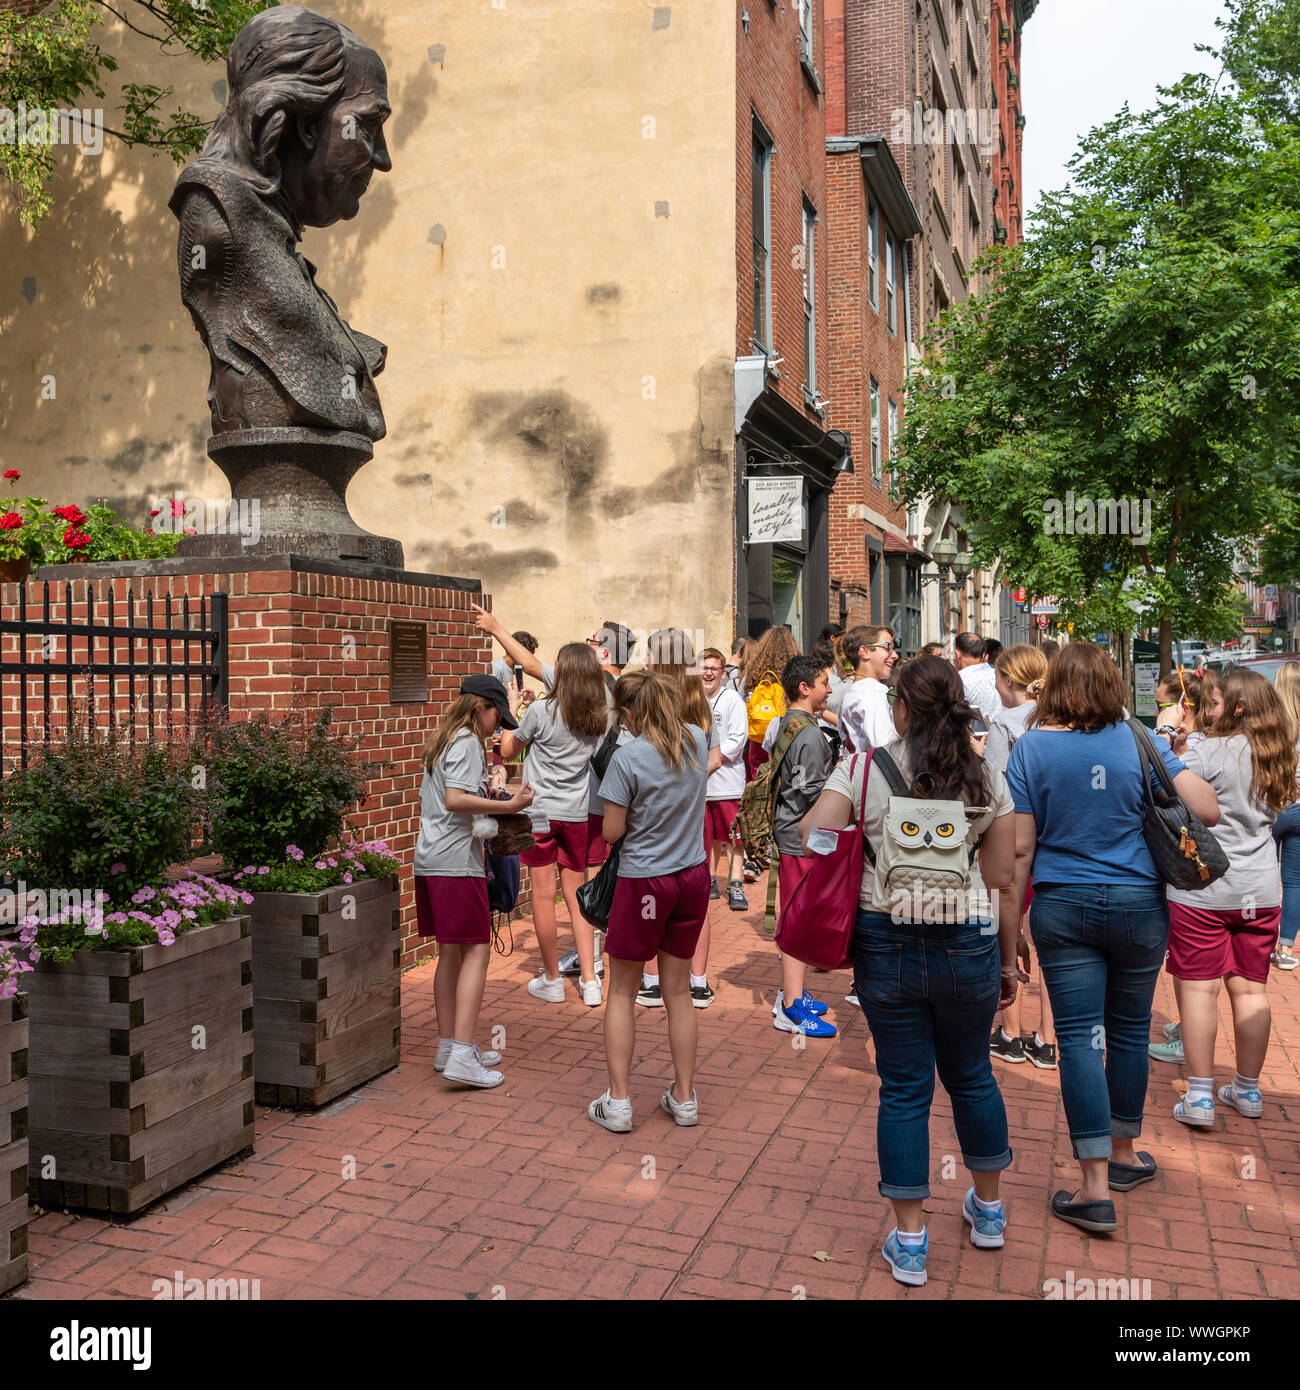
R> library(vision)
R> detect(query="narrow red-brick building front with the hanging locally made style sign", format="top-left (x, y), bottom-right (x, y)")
top-left (736, 0), bottom-right (850, 646)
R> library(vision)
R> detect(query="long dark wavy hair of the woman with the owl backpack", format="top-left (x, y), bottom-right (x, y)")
top-left (895, 656), bottom-right (987, 806)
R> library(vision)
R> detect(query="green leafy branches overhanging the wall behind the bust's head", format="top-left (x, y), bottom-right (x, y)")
top-left (0, 0), bottom-right (277, 227)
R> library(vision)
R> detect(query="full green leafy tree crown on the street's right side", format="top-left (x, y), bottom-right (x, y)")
top-left (900, 75), bottom-right (1300, 670)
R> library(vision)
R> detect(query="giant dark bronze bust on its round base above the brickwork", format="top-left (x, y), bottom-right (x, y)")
top-left (170, 6), bottom-right (402, 564)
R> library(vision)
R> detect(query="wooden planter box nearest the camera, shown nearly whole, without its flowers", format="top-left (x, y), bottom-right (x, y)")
top-left (24, 916), bottom-right (253, 1212)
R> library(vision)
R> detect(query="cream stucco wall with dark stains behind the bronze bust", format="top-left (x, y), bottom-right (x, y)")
top-left (0, 0), bottom-right (736, 652)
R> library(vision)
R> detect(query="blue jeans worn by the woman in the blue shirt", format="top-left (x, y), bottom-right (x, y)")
top-left (1029, 883), bottom-right (1169, 1158)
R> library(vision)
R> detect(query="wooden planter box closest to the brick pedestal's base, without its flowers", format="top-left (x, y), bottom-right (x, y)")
top-left (249, 876), bottom-right (402, 1109)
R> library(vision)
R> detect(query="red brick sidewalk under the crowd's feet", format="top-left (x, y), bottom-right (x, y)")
top-left (13, 884), bottom-right (1300, 1300)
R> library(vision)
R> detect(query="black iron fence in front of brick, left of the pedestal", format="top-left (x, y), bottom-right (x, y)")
top-left (0, 580), bottom-right (228, 767)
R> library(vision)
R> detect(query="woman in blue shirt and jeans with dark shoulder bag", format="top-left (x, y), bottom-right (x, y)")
top-left (1007, 642), bottom-right (1219, 1232)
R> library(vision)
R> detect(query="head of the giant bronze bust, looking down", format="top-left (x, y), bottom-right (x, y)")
top-left (202, 6), bottom-right (392, 227)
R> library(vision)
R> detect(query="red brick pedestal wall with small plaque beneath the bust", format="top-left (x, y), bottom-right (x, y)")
top-left (10, 555), bottom-right (494, 966)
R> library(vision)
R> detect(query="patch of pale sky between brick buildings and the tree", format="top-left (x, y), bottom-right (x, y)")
top-left (1021, 0), bottom-right (1224, 222)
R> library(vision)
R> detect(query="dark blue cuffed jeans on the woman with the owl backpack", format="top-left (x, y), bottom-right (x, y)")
top-left (854, 912), bottom-right (1011, 1201)
